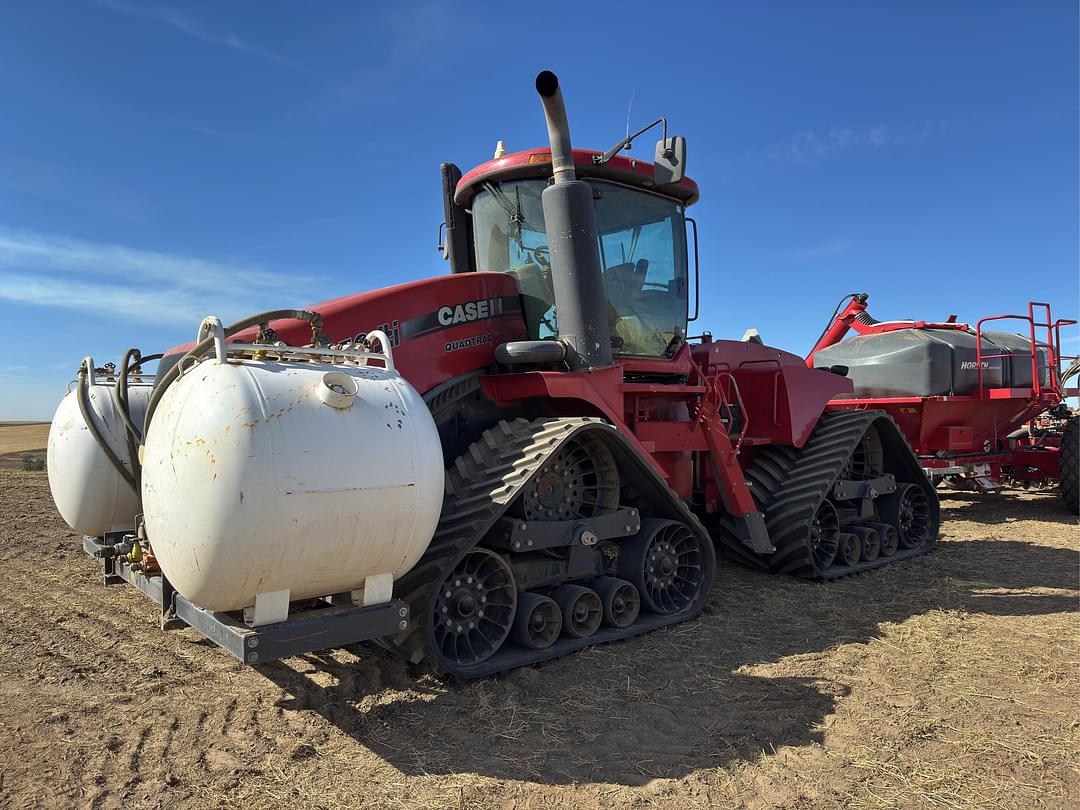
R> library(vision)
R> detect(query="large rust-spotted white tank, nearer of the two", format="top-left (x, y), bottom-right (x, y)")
top-left (143, 333), bottom-right (444, 624)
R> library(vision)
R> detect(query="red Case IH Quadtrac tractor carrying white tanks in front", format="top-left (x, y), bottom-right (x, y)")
top-left (49, 72), bottom-right (939, 678)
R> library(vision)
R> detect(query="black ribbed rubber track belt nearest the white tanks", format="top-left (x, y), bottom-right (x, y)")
top-left (380, 417), bottom-right (715, 678)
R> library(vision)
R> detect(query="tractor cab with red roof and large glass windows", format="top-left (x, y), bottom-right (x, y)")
top-left (443, 147), bottom-right (698, 357)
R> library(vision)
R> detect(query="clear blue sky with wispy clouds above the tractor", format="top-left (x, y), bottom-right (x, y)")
top-left (0, 0), bottom-right (1080, 419)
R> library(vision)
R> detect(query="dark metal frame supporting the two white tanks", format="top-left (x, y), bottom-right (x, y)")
top-left (82, 532), bottom-right (409, 664)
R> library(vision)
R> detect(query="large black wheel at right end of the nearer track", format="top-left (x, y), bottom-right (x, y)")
top-left (619, 517), bottom-right (706, 616)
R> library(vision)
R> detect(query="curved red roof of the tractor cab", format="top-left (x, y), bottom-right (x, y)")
top-left (454, 149), bottom-right (700, 208)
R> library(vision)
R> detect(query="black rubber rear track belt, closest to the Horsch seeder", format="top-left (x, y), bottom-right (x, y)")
top-left (714, 410), bottom-right (937, 580)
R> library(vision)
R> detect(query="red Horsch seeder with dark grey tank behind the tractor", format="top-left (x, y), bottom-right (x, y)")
top-left (807, 293), bottom-right (1080, 512)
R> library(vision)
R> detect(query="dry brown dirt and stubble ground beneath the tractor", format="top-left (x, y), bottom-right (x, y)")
top-left (0, 460), bottom-right (1080, 810)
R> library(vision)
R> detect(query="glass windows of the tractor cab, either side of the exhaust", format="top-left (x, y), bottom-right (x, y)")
top-left (472, 179), bottom-right (688, 357)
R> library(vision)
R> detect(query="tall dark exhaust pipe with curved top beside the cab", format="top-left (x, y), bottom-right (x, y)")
top-left (537, 70), bottom-right (612, 369)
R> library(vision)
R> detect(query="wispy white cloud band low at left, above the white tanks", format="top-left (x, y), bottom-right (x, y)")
top-left (0, 228), bottom-right (319, 328)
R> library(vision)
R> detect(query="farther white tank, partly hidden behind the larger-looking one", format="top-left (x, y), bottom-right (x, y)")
top-left (46, 357), bottom-right (151, 537)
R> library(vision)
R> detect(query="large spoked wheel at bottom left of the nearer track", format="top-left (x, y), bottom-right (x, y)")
top-left (431, 549), bottom-right (517, 667)
